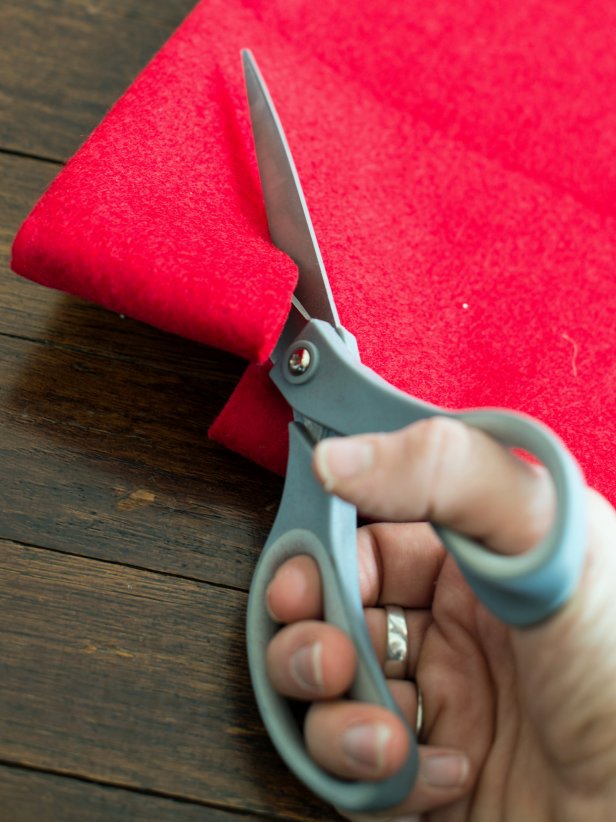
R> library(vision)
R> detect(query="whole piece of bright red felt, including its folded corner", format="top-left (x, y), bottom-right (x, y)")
top-left (13, 0), bottom-right (616, 501)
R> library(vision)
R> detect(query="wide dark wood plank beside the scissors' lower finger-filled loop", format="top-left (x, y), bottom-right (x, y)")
top-left (0, 542), bottom-right (332, 819)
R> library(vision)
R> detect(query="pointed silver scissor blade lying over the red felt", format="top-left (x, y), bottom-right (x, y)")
top-left (242, 49), bottom-right (340, 326)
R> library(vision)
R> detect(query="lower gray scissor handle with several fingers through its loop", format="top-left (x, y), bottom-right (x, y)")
top-left (247, 423), bottom-right (418, 812)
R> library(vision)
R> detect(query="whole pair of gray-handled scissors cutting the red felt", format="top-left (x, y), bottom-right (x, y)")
top-left (242, 50), bottom-right (585, 812)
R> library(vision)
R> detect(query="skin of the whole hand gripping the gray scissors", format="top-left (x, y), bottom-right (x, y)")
top-left (267, 419), bottom-right (616, 822)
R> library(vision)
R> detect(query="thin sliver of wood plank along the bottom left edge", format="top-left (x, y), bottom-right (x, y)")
top-left (0, 766), bottom-right (272, 822)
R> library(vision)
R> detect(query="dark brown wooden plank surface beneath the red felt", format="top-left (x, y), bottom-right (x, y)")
top-left (0, 0), bottom-right (335, 822)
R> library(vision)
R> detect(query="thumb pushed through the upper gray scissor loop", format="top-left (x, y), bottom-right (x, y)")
top-left (314, 417), bottom-right (554, 554)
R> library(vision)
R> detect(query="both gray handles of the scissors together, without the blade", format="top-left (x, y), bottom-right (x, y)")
top-left (247, 320), bottom-right (585, 811)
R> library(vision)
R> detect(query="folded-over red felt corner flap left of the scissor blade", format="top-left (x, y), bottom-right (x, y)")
top-left (12, 2), bottom-right (296, 361)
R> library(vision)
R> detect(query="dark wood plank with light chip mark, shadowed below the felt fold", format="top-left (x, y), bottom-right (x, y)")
top-left (0, 336), bottom-right (282, 590)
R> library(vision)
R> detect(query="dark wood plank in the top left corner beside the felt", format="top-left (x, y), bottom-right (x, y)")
top-left (0, 0), bottom-right (195, 160)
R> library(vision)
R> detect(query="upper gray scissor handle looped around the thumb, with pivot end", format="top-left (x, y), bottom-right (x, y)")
top-left (271, 320), bottom-right (586, 627)
